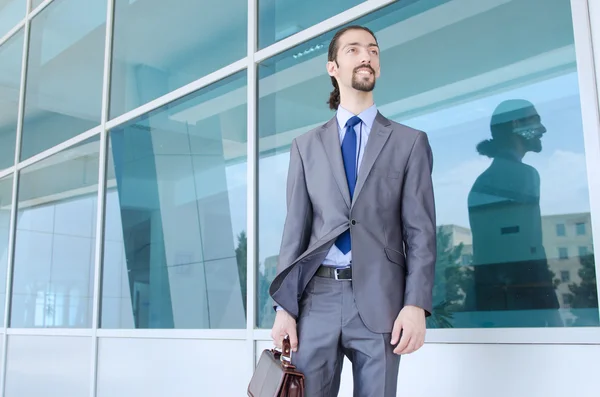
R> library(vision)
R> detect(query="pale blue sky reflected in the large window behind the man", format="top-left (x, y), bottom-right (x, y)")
top-left (252, 73), bottom-right (589, 263)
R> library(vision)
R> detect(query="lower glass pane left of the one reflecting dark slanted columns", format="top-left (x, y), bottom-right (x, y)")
top-left (10, 136), bottom-right (100, 328)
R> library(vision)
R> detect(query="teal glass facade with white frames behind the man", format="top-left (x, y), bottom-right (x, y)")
top-left (0, 0), bottom-right (600, 395)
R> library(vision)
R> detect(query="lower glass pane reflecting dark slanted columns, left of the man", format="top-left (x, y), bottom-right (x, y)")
top-left (102, 72), bottom-right (247, 328)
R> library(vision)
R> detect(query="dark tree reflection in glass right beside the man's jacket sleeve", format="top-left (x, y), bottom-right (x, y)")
top-left (427, 226), bottom-right (473, 328)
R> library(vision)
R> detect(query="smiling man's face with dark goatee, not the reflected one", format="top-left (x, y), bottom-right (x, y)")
top-left (327, 29), bottom-right (380, 92)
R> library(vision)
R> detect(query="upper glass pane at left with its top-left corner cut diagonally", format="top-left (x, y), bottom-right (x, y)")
top-left (21, 0), bottom-right (106, 160)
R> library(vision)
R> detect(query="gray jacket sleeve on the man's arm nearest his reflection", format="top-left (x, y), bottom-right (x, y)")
top-left (402, 132), bottom-right (436, 316)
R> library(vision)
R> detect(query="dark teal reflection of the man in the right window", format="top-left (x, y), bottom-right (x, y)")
top-left (467, 100), bottom-right (562, 326)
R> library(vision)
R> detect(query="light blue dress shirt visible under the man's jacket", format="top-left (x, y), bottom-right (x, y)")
top-left (323, 105), bottom-right (377, 267)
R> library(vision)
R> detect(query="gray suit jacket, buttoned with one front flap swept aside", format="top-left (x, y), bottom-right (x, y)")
top-left (269, 113), bottom-right (436, 333)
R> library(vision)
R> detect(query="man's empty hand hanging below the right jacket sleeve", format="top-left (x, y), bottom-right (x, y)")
top-left (391, 306), bottom-right (425, 354)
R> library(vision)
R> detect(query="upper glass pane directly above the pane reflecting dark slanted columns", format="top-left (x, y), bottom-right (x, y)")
top-left (110, 0), bottom-right (248, 118)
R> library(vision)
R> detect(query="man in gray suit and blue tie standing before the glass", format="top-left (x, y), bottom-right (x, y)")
top-left (270, 26), bottom-right (436, 397)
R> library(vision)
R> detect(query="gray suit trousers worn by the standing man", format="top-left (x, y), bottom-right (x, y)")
top-left (292, 276), bottom-right (400, 397)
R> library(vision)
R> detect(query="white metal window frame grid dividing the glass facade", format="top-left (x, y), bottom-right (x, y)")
top-left (0, 0), bottom-right (600, 397)
